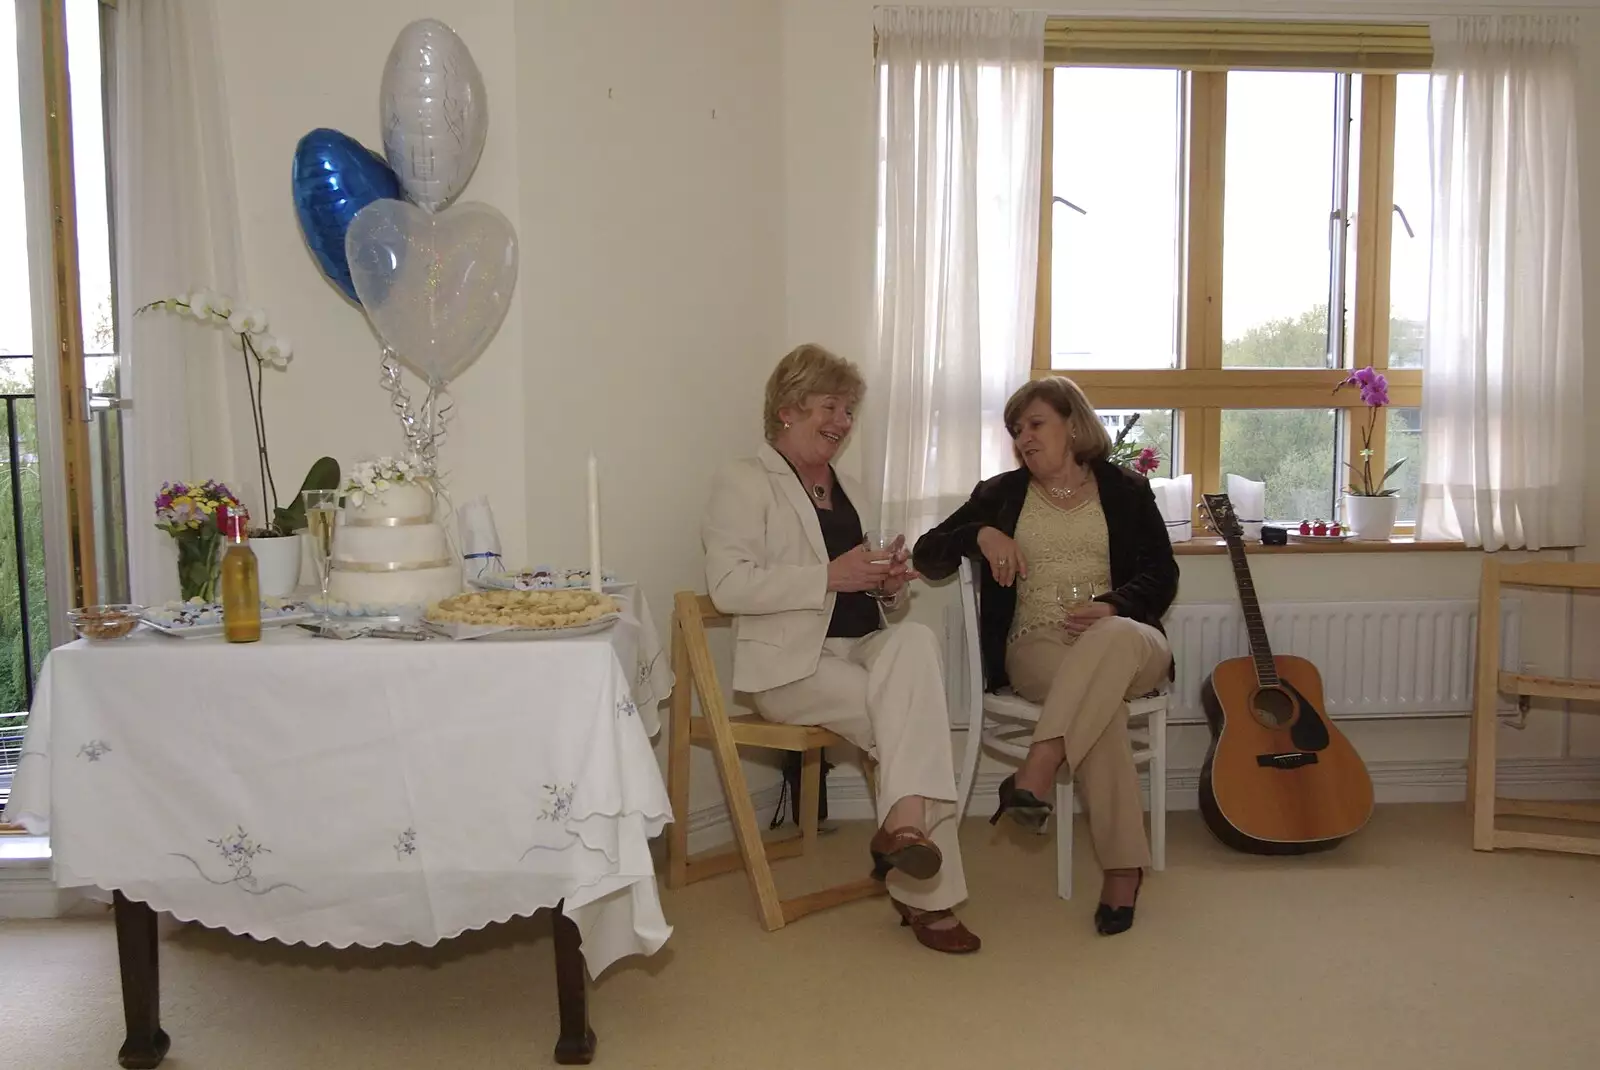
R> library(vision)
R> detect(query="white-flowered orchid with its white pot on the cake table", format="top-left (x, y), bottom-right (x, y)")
top-left (134, 289), bottom-right (339, 598)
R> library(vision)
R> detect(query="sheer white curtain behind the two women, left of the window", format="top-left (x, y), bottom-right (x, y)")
top-left (866, 8), bottom-right (1045, 541)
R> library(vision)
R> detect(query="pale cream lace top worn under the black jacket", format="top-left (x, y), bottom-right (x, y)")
top-left (1006, 486), bottom-right (1110, 643)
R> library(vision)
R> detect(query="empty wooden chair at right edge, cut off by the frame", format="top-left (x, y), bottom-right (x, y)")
top-left (1467, 555), bottom-right (1600, 854)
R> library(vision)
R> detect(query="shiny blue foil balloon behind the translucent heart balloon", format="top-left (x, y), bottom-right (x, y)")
top-left (293, 126), bottom-right (400, 304)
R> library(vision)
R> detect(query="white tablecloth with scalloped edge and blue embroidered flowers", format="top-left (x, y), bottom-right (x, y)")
top-left (6, 589), bottom-right (672, 974)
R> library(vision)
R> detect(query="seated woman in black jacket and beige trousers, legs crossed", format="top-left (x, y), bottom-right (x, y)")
top-left (912, 376), bottom-right (1178, 934)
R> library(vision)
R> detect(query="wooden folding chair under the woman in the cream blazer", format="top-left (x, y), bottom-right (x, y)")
top-left (667, 590), bottom-right (885, 931)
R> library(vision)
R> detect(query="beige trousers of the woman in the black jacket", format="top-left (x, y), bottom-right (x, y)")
top-left (1005, 617), bottom-right (1173, 870)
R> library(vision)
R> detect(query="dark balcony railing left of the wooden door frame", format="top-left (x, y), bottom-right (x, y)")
top-left (0, 393), bottom-right (50, 800)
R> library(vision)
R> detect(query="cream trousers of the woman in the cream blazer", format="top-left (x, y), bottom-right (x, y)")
top-left (752, 624), bottom-right (966, 910)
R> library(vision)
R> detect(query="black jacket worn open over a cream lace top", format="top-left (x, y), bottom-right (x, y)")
top-left (912, 461), bottom-right (1178, 691)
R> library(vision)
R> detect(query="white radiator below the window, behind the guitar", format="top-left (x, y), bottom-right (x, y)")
top-left (944, 598), bottom-right (1522, 725)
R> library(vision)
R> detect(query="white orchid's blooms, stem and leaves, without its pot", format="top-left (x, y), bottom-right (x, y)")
top-left (134, 289), bottom-right (339, 536)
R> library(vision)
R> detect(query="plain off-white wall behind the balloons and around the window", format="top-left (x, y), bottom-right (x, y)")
top-left (206, 0), bottom-right (1600, 803)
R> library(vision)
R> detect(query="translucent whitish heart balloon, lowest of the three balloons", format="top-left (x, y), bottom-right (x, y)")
top-left (344, 200), bottom-right (517, 387)
